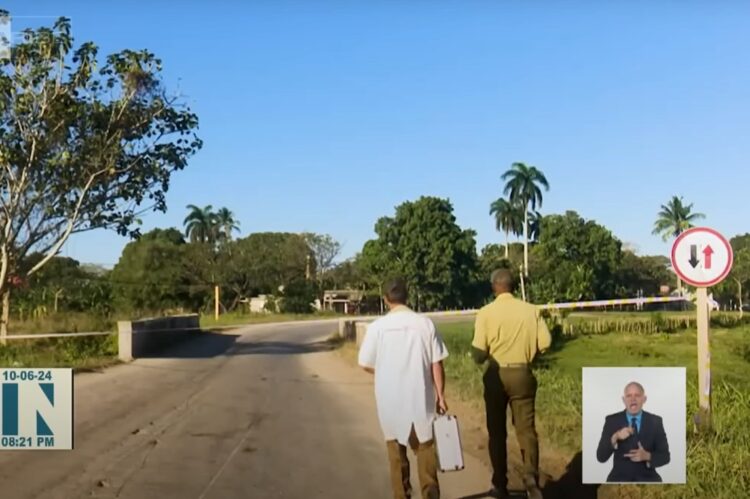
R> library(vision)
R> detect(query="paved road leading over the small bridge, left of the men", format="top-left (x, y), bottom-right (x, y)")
top-left (0, 323), bottom-right (489, 499)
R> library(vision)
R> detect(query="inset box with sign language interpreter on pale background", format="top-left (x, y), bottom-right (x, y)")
top-left (582, 367), bottom-right (686, 484)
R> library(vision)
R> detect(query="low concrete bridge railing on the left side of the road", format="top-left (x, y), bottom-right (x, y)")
top-left (117, 314), bottom-right (200, 362)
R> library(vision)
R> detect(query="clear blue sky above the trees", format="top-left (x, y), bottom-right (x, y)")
top-left (6, 0), bottom-right (750, 265)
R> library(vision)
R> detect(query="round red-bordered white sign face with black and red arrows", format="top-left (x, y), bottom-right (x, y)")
top-left (672, 227), bottom-right (733, 288)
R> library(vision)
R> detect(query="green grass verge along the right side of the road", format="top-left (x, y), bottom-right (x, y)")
top-left (440, 323), bottom-right (750, 499)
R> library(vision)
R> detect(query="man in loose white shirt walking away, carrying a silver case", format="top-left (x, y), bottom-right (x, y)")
top-left (359, 279), bottom-right (448, 499)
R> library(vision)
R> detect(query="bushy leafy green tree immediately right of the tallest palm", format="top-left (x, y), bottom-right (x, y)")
top-left (530, 211), bottom-right (622, 302)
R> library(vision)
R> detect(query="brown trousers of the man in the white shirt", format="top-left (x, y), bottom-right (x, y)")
top-left (386, 427), bottom-right (440, 499)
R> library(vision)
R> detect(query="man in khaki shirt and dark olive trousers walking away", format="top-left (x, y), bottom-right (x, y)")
top-left (472, 269), bottom-right (552, 499)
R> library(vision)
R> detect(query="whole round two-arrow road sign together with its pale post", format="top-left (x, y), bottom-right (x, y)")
top-left (672, 227), bottom-right (733, 430)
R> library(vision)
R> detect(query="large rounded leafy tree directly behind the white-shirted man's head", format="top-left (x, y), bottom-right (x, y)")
top-left (361, 197), bottom-right (478, 310)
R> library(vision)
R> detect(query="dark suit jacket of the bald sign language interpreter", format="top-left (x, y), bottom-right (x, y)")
top-left (596, 411), bottom-right (669, 482)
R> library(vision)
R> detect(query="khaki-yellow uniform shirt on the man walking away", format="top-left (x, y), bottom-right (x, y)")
top-left (471, 293), bottom-right (552, 365)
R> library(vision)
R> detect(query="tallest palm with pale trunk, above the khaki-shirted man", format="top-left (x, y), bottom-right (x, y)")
top-left (501, 163), bottom-right (549, 277)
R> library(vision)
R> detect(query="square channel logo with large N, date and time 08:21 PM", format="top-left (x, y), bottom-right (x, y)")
top-left (0, 368), bottom-right (73, 450)
